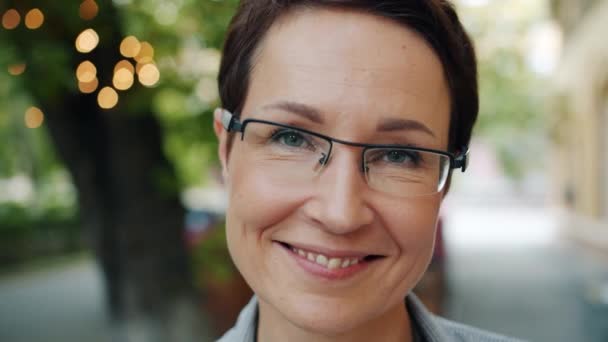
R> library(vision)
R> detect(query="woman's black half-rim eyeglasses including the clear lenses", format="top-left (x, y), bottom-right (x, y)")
top-left (221, 110), bottom-right (468, 197)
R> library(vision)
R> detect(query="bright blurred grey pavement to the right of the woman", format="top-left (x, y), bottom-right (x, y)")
top-left (445, 200), bottom-right (608, 342)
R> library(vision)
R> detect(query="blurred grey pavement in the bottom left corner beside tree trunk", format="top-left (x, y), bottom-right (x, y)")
top-left (0, 259), bottom-right (110, 342)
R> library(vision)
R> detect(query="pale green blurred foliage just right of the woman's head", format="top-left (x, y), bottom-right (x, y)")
top-left (476, 50), bottom-right (546, 179)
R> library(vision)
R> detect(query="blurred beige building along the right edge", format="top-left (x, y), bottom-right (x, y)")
top-left (549, 0), bottom-right (608, 246)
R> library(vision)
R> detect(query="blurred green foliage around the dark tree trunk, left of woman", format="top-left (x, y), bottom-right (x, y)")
top-left (0, 0), bottom-right (238, 264)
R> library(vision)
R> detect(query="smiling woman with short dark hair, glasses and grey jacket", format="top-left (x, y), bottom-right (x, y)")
top-left (214, 0), bottom-right (506, 341)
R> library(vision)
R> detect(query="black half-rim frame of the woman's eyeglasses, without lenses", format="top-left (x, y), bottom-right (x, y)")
top-left (221, 109), bottom-right (469, 172)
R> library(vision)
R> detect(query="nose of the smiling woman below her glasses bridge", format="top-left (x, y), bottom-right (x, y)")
top-left (307, 147), bottom-right (374, 234)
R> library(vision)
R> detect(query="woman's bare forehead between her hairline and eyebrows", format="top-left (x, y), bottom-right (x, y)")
top-left (243, 9), bottom-right (450, 143)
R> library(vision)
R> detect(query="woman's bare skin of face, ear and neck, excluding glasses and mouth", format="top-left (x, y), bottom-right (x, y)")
top-left (214, 9), bottom-right (450, 341)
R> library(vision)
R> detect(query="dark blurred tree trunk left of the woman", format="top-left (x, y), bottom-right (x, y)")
top-left (4, 1), bottom-right (209, 341)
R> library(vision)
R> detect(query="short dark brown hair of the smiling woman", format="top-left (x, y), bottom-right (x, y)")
top-left (218, 0), bottom-right (479, 151)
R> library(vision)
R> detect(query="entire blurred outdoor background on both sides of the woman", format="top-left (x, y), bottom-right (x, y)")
top-left (0, 0), bottom-right (608, 342)
